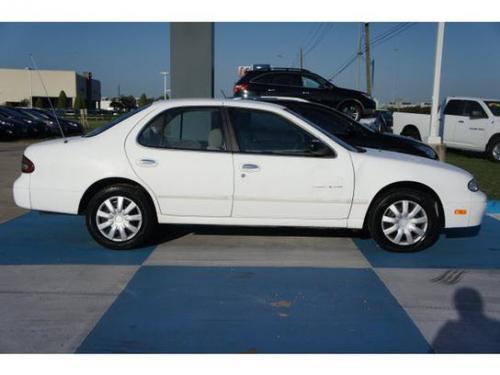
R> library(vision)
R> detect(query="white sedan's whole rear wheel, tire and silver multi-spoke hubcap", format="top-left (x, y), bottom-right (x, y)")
top-left (86, 184), bottom-right (156, 250)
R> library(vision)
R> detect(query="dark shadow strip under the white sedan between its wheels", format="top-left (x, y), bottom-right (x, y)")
top-left (146, 224), bottom-right (369, 245)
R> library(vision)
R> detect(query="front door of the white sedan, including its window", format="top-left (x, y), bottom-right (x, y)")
top-left (227, 107), bottom-right (354, 219)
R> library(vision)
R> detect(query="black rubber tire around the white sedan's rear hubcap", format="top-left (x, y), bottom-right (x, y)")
top-left (86, 184), bottom-right (157, 250)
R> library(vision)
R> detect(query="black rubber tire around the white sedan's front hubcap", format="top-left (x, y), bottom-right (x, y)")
top-left (367, 188), bottom-right (442, 252)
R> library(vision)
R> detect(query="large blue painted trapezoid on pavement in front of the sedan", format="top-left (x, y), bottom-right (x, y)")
top-left (78, 266), bottom-right (431, 353)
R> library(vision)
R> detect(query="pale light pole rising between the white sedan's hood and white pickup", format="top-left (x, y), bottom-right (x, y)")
top-left (427, 22), bottom-right (446, 160)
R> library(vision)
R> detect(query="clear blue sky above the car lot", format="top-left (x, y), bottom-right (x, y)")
top-left (0, 22), bottom-right (500, 102)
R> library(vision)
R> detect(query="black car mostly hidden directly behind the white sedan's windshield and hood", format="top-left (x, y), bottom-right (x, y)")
top-left (250, 97), bottom-right (438, 159)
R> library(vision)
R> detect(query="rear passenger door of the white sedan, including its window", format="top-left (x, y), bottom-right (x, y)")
top-left (126, 107), bottom-right (233, 217)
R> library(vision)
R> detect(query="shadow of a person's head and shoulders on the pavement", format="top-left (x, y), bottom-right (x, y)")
top-left (432, 288), bottom-right (500, 353)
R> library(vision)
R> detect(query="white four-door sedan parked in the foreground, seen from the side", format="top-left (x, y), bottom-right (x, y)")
top-left (14, 99), bottom-right (486, 251)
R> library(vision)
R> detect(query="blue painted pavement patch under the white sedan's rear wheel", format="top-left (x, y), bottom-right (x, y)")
top-left (0, 212), bottom-right (154, 265)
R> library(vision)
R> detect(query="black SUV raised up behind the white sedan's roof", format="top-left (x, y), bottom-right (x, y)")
top-left (234, 68), bottom-right (376, 120)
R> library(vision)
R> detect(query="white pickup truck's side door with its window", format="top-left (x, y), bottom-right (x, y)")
top-left (455, 100), bottom-right (489, 150)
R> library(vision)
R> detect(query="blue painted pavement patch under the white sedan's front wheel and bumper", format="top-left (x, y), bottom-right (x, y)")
top-left (353, 216), bottom-right (500, 269)
